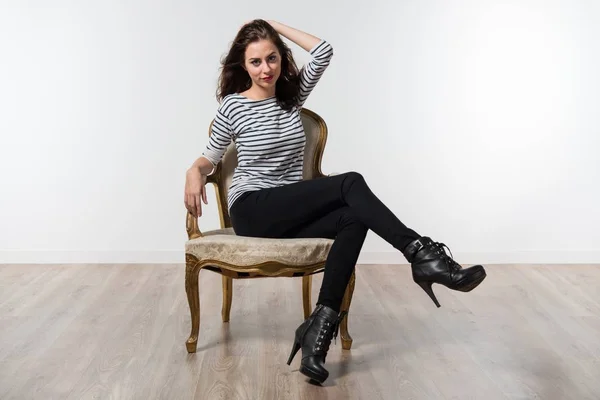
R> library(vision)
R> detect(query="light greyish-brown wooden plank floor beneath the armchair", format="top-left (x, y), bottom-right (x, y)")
top-left (0, 264), bottom-right (600, 400)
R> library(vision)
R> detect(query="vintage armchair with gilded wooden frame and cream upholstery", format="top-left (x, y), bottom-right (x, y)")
top-left (180, 108), bottom-right (355, 353)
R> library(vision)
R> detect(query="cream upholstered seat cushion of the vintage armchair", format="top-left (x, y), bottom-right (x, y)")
top-left (185, 228), bottom-right (333, 267)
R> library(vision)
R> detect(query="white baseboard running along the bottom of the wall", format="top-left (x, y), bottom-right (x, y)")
top-left (0, 250), bottom-right (600, 264)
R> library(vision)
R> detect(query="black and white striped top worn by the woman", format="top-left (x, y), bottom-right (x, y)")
top-left (202, 40), bottom-right (333, 209)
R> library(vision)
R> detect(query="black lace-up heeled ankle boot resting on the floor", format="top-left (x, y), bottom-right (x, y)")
top-left (287, 304), bottom-right (345, 383)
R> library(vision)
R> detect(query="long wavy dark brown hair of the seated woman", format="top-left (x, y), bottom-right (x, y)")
top-left (216, 19), bottom-right (300, 110)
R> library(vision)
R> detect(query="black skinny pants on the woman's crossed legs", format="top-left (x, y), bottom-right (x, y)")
top-left (230, 172), bottom-right (421, 312)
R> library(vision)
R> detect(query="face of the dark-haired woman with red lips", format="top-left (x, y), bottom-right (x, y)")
top-left (244, 40), bottom-right (281, 90)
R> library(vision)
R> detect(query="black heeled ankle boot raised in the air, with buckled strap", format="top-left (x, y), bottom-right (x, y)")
top-left (403, 236), bottom-right (486, 307)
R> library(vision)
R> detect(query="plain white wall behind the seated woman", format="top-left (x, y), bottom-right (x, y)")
top-left (0, 0), bottom-right (600, 263)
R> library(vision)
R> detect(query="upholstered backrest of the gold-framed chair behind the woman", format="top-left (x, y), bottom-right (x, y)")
top-left (208, 108), bottom-right (327, 228)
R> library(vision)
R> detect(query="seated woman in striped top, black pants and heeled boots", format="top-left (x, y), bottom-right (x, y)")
top-left (185, 20), bottom-right (486, 383)
